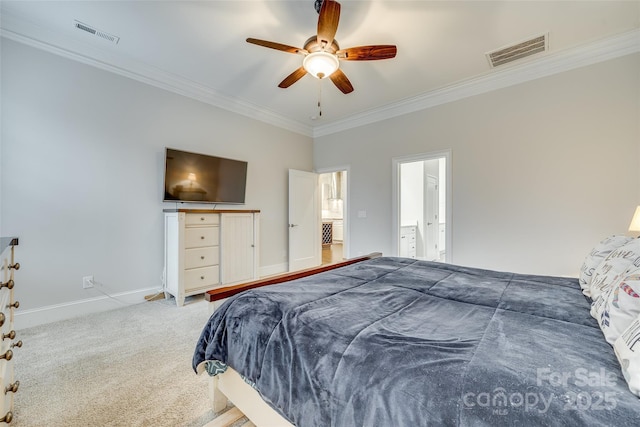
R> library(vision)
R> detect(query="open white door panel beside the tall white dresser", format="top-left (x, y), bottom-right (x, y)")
top-left (289, 169), bottom-right (322, 271)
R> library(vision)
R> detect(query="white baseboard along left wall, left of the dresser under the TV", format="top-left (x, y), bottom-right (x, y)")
top-left (14, 287), bottom-right (162, 330)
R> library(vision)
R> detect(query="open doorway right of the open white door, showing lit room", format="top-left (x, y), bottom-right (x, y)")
top-left (318, 168), bottom-right (348, 264)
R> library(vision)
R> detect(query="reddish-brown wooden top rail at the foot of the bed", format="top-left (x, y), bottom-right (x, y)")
top-left (204, 252), bottom-right (382, 302)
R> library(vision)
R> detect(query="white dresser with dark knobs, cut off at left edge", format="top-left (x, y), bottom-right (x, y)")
top-left (0, 237), bottom-right (22, 425)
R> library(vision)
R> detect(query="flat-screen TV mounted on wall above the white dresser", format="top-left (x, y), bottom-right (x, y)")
top-left (164, 148), bottom-right (247, 204)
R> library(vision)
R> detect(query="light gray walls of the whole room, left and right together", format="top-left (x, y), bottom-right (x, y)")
top-left (0, 39), bottom-right (640, 324)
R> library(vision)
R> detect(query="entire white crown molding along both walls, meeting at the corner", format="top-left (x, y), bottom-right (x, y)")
top-left (0, 9), bottom-right (640, 138)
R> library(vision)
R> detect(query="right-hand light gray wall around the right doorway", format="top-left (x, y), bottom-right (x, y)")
top-left (314, 54), bottom-right (640, 276)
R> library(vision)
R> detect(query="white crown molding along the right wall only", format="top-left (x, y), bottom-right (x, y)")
top-left (313, 29), bottom-right (640, 138)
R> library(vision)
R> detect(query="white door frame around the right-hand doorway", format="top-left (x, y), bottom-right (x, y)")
top-left (391, 149), bottom-right (453, 263)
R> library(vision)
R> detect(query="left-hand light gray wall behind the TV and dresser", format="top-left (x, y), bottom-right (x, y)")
top-left (0, 39), bottom-right (312, 320)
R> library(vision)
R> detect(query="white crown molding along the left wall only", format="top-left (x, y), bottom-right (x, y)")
top-left (0, 13), bottom-right (313, 137)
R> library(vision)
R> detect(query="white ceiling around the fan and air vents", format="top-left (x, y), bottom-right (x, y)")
top-left (0, 0), bottom-right (640, 136)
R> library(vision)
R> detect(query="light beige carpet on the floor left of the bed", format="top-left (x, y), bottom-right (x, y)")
top-left (12, 297), bottom-right (245, 427)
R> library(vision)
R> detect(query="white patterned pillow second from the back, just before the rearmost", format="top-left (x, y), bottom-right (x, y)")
top-left (589, 239), bottom-right (640, 301)
